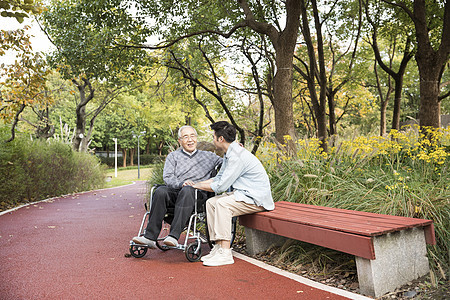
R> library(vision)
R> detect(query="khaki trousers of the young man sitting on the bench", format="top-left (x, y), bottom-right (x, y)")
top-left (206, 193), bottom-right (264, 241)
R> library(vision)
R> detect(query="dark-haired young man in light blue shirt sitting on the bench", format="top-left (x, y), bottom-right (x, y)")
top-left (193, 121), bottom-right (275, 266)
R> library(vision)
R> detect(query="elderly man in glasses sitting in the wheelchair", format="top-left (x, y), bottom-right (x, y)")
top-left (133, 126), bottom-right (222, 248)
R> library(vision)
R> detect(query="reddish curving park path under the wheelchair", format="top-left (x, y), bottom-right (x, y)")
top-left (0, 182), bottom-right (367, 300)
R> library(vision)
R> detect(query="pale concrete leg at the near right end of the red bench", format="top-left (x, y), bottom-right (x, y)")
top-left (356, 228), bottom-right (430, 297)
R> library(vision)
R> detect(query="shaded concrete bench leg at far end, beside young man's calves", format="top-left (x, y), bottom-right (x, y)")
top-left (245, 227), bottom-right (287, 255)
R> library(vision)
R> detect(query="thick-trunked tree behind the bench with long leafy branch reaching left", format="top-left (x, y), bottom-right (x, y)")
top-left (134, 0), bottom-right (301, 147)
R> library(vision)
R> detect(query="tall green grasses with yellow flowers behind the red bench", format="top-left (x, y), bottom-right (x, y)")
top-left (259, 126), bottom-right (450, 284)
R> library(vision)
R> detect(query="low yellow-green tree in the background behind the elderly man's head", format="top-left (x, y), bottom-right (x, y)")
top-left (91, 63), bottom-right (209, 165)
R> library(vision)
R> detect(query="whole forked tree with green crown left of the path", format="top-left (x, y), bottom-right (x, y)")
top-left (42, 0), bottom-right (148, 151)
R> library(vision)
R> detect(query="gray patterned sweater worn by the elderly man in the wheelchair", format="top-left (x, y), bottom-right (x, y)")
top-left (163, 148), bottom-right (222, 189)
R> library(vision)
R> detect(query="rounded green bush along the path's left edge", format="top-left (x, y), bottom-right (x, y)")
top-left (0, 127), bottom-right (105, 210)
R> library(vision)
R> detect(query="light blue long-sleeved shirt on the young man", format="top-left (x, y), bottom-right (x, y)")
top-left (211, 142), bottom-right (275, 210)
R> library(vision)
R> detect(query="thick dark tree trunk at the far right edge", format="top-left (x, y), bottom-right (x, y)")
top-left (382, 0), bottom-right (450, 128)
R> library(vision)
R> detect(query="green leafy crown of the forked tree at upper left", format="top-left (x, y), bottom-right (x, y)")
top-left (41, 0), bottom-right (147, 83)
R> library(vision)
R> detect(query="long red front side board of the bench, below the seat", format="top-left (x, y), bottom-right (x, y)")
top-left (239, 213), bottom-right (375, 259)
